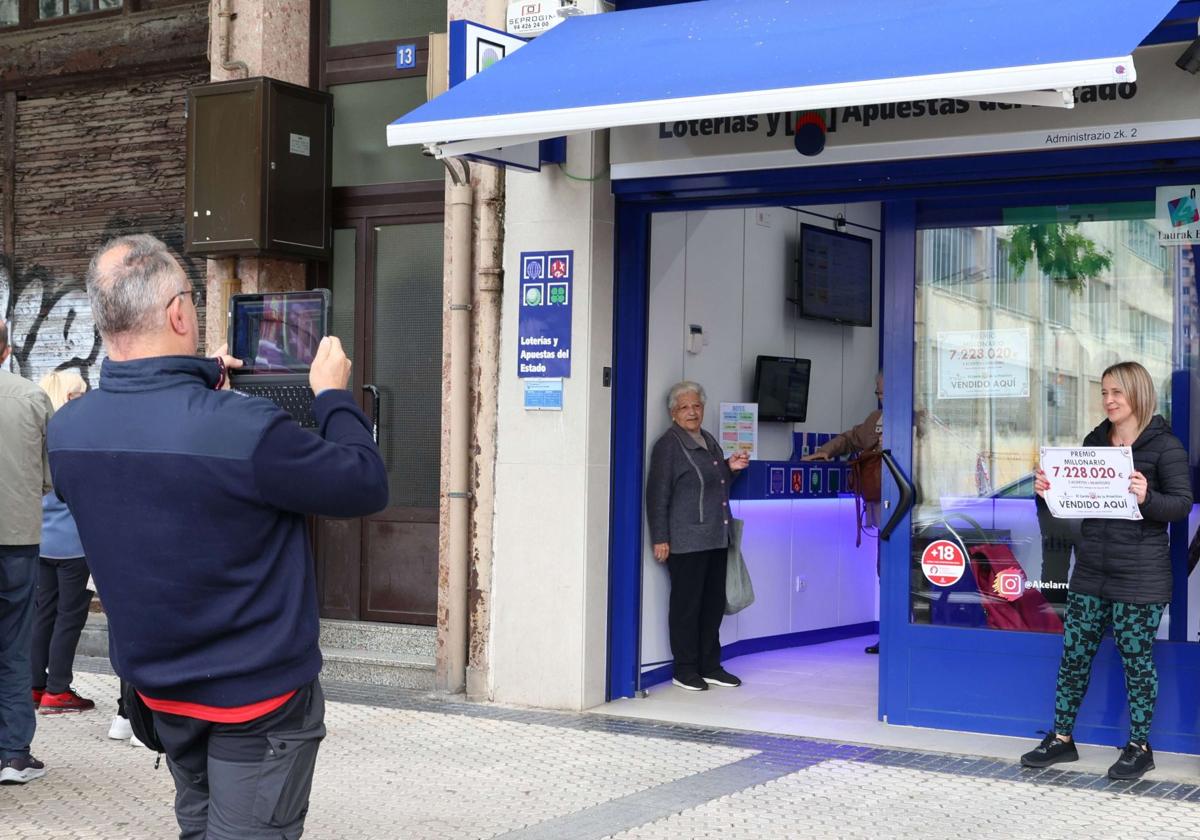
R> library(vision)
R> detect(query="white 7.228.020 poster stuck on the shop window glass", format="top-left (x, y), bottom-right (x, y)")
top-left (937, 328), bottom-right (1030, 400)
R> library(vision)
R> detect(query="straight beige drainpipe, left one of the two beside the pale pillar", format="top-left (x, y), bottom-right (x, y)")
top-left (439, 161), bottom-right (474, 694)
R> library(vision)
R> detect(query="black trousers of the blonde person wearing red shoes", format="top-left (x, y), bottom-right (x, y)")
top-left (29, 557), bottom-right (91, 694)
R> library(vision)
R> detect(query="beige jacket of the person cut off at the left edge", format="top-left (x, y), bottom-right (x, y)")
top-left (0, 371), bottom-right (54, 546)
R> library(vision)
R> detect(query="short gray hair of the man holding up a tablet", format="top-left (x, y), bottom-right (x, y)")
top-left (88, 233), bottom-right (180, 338)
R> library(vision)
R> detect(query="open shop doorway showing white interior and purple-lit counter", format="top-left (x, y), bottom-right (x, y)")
top-left (624, 203), bottom-right (882, 737)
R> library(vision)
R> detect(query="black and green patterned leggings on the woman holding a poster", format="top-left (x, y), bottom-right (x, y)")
top-left (1054, 592), bottom-right (1166, 743)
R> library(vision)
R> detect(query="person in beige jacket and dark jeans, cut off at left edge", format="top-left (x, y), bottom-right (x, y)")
top-left (0, 320), bottom-right (54, 785)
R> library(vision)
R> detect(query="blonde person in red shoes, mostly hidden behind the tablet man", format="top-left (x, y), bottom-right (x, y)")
top-left (30, 370), bottom-right (96, 714)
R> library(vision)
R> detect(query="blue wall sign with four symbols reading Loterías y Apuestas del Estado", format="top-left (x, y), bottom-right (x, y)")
top-left (517, 251), bottom-right (575, 378)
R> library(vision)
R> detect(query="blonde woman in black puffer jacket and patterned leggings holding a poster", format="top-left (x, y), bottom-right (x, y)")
top-left (1021, 361), bottom-right (1192, 779)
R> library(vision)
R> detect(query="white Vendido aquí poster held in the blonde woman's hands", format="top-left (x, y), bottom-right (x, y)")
top-left (1040, 446), bottom-right (1141, 520)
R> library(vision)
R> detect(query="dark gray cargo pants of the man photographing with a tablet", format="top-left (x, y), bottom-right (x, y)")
top-left (154, 679), bottom-right (325, 840)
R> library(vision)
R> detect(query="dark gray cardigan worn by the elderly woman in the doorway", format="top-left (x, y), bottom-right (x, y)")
top-left (646, 424), bottom-right (734, 554)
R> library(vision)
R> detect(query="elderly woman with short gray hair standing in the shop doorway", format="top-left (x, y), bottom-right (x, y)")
top-left (646, 382), bottom-right (750, 691)
